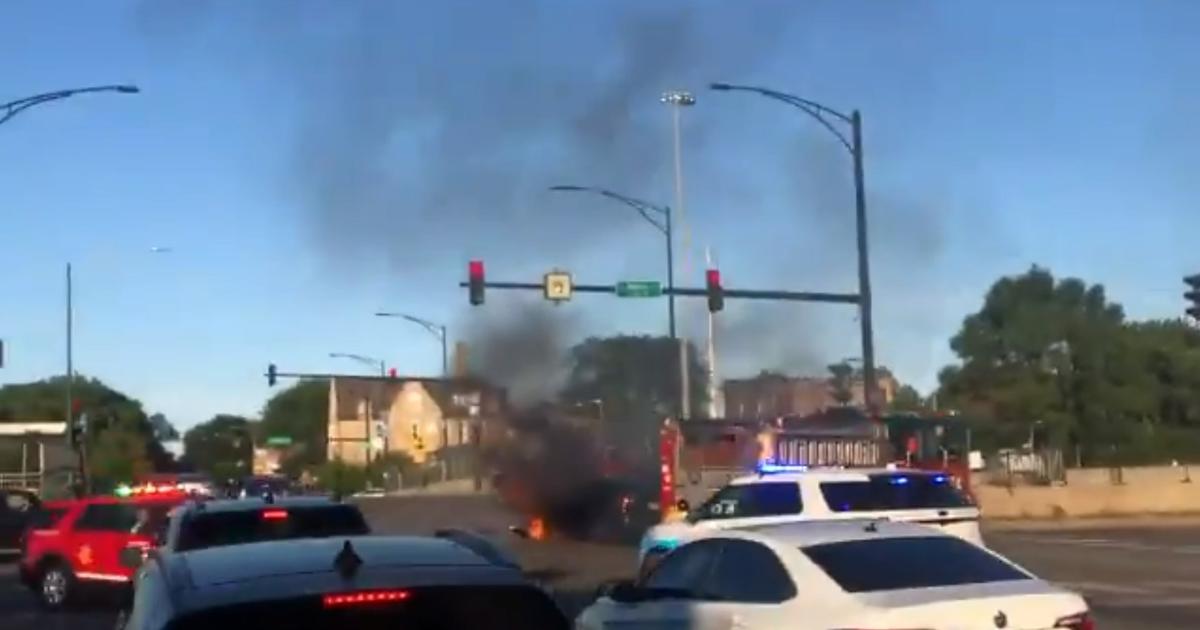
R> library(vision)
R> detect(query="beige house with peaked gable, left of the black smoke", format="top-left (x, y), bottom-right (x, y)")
top-left (328, 377), bottom-right (505, 464)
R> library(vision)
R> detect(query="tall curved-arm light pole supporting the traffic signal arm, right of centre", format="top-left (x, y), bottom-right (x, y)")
top-left (709, 83), bottom-right (880, 414)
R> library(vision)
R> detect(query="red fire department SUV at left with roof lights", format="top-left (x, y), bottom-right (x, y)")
top-left (19, 493), bottom-right (187, 608)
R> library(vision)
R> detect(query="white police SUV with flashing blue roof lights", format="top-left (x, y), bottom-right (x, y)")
top-left (638, 466), bottom-right (983, 569)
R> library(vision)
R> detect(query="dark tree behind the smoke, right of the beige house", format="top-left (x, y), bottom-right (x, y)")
top-left (559, 335), bottom-right (708, 442)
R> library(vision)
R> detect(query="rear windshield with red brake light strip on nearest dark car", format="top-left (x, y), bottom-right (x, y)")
top-left (167, 586), bottom-right (570, 630)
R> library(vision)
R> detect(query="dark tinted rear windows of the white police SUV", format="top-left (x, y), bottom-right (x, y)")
top-left (821, 474), bottom-right (973, 512)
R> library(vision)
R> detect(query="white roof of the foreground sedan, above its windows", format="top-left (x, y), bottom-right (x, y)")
top-left (702, 518), bottom-right (954, 547)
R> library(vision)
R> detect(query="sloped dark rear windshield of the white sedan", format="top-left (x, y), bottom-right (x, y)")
top-left (803, 536), bottom-right (1032, 593)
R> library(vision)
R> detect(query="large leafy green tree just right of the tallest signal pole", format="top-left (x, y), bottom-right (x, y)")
top-left (940, 266), bottom-right (1132, 445)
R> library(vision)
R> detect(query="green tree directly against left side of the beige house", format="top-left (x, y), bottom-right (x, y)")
top-left (260, 379), bottom-right (329, 473)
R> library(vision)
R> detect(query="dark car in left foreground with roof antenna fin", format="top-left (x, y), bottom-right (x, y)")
top-left (125, 536), bottom-right (570, 630)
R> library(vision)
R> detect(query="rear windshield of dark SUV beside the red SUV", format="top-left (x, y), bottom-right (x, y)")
top-left (178, 504), bottom-right (370, 551)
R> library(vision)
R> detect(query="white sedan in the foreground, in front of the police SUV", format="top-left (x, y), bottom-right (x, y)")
top-left (575, 521), bottom-right (1094, 630)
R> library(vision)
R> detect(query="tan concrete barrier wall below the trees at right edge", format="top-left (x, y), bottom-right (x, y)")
top-left (972, 467), bottom-right (1200, 518)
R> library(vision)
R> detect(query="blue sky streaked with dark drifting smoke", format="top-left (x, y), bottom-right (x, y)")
top-left (0, 0), bottom-right (1200, 427)
